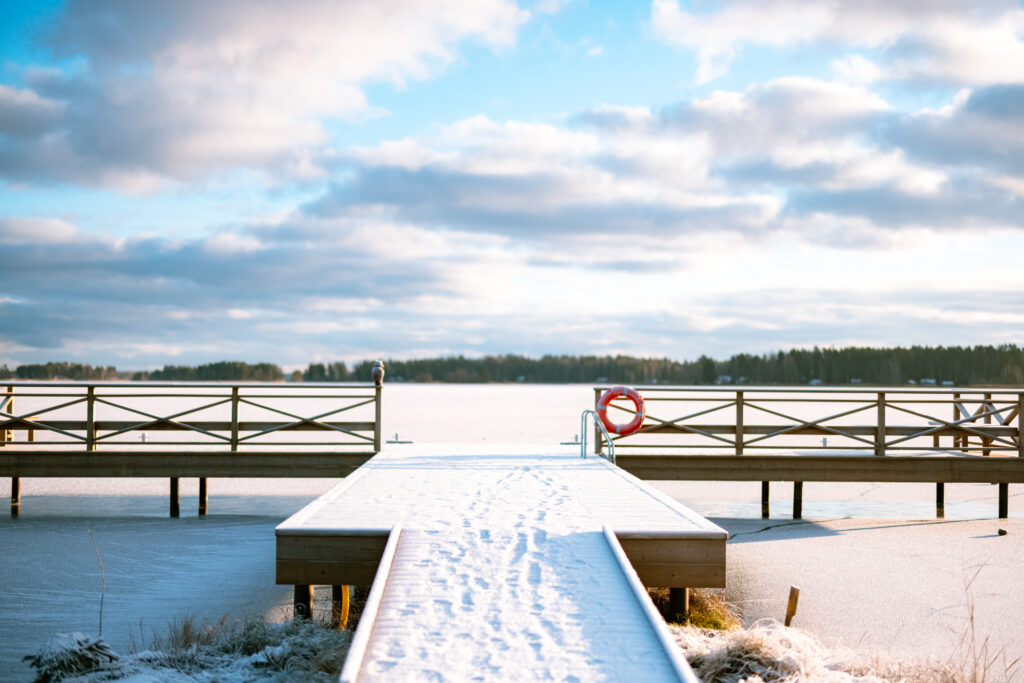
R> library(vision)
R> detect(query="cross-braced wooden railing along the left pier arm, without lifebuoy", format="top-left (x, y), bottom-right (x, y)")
top-left (0, 382), bottom-right (381, 453)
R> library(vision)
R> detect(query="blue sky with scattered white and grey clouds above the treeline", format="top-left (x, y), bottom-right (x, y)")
top-left (0, 0), bottom-right (1024, 370)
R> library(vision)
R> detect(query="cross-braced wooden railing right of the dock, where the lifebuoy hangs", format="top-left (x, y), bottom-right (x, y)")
top-left (594, 386), bottom-right (1024, 458)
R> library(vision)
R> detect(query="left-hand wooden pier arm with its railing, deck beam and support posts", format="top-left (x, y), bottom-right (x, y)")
top-left (0, 382), bottom-right (383, 517)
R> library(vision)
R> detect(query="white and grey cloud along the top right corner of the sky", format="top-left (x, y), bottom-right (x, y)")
top-left (651, 0), bottom-right (1024, 84)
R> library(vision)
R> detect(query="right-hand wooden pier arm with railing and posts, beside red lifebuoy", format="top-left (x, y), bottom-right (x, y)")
top-left (594, 386), bottom-right (1024, 518)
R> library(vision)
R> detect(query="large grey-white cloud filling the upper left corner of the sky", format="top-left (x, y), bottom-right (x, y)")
top-left (8, 0), bottom-right (528, 191)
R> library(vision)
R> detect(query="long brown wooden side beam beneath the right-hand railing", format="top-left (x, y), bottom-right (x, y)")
top-left (616, 454), bottom-right (1024, 483)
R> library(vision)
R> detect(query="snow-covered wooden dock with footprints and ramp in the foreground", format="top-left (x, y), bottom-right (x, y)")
top-left (276, 444), bottom-right (728, 680)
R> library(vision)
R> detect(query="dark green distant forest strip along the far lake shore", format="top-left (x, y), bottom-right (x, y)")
top-left (6, 344), bottom-right (1024, 386)
